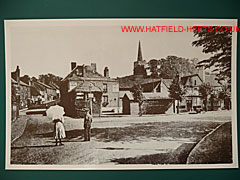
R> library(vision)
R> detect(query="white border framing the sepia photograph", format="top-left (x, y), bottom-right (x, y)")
top-left (4, 19), bottom-right (238, 170)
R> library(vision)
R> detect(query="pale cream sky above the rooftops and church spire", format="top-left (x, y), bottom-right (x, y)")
top-left (6, 20), bottom-right (234, 77)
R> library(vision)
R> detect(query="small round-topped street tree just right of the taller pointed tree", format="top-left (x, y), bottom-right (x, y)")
top-left (199, 83), bottom-right (213, 111)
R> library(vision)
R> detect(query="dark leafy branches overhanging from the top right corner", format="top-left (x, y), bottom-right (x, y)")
top-left (192, 26), bottom-right (232, 82)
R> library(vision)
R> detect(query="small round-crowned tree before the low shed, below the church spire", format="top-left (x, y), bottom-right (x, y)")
top-left (131, 84), bottom-right (144, 116)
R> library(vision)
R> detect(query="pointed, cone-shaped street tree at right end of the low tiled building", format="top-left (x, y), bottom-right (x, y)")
top-left (169, 73), bottom-right (185, 114)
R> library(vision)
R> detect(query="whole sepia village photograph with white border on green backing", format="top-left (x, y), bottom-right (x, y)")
top-left (4, 19), bottom-right (240, 170)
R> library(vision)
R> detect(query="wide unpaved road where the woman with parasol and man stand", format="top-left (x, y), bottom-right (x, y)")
top-left (11, 111), bottom-right (231, 166)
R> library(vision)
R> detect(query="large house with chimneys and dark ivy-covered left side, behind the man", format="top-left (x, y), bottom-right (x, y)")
top-left (60, 62), bottom-right (119, 117)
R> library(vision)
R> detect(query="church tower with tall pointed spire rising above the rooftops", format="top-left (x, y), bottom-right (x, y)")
top-left (133, 41), bottom-right (147, 77)
